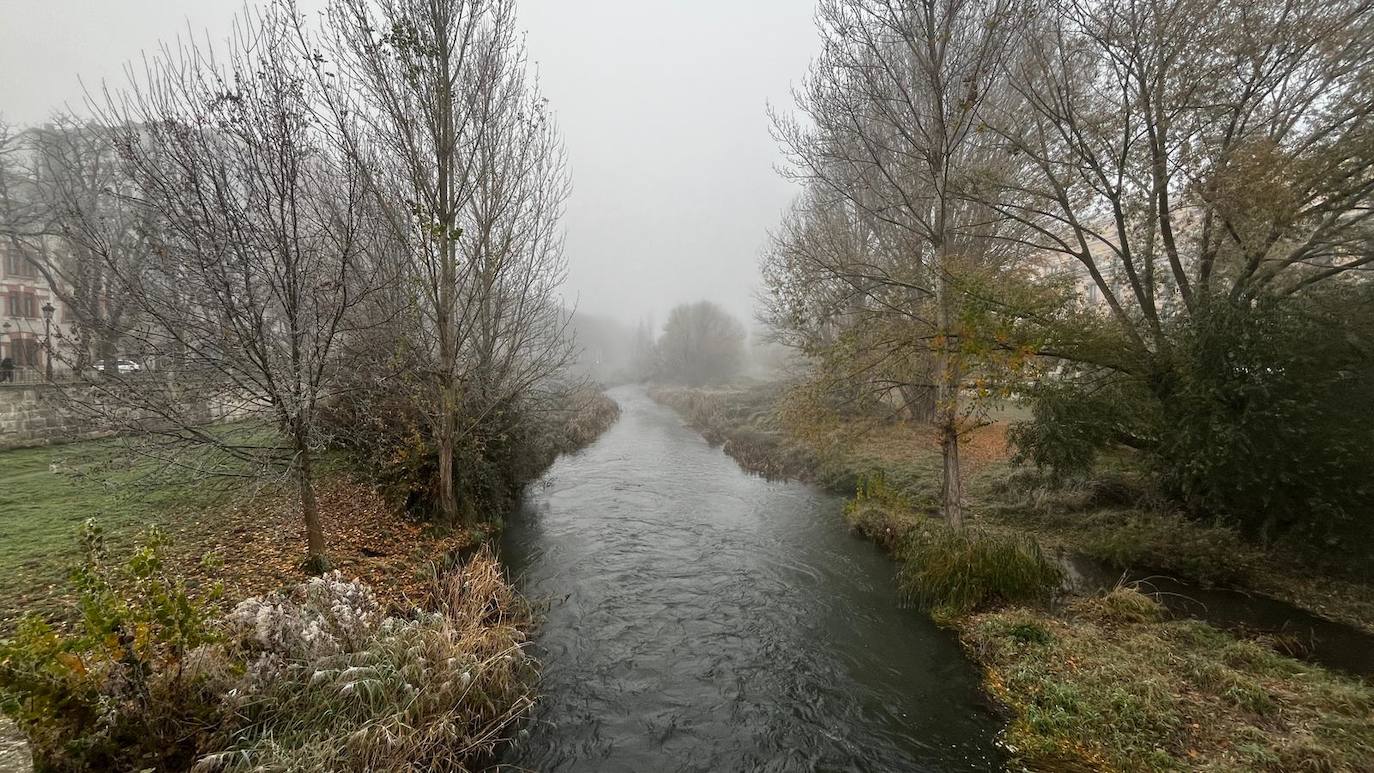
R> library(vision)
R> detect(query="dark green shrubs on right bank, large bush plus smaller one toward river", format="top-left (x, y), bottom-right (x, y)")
top-left (1010, 286), bottom-right (1374, 545)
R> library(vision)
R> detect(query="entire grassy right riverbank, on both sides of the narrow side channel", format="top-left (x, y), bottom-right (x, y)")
top-left (653, 386), bottom-right (1374, 772)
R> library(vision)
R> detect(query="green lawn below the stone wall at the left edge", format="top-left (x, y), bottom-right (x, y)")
top-left (0, 442), bottom-right (222, 632)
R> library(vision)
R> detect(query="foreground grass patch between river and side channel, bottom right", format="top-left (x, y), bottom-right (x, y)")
top-left (956, 589), bottom-right (1374, 772)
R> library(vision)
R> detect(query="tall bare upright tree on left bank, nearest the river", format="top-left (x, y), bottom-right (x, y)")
top-left (319, 0), bottom-right (572, 522)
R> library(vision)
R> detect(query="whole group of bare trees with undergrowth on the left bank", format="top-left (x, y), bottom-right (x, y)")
top-left (0, 0), bottom-right (585, 567)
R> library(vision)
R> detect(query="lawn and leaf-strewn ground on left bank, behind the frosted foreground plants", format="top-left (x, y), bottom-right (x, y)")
top-left (0, 442), bottom-right (473, 636)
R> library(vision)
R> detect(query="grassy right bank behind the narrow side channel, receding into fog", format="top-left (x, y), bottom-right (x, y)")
top-left (650, 384), bottom-right (1374, 633)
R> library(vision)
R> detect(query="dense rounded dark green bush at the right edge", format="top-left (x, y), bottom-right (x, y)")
top-left (1153, 299), bottom-right (1374, 540)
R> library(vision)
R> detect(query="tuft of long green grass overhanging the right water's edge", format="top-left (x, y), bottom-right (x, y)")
top-left (897, 522), bottom-right (1061, 616)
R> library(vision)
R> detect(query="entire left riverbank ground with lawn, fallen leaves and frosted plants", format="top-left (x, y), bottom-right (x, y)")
top-left (0, 394), bottom-right (618, 773)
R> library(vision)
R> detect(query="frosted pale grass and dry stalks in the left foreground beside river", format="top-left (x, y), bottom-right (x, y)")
top-left (194, 553), bottom-right (534, 772)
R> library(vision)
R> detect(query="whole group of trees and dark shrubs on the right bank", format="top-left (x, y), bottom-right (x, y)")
top-left (764, 0), bottom-right (1374, 541)
